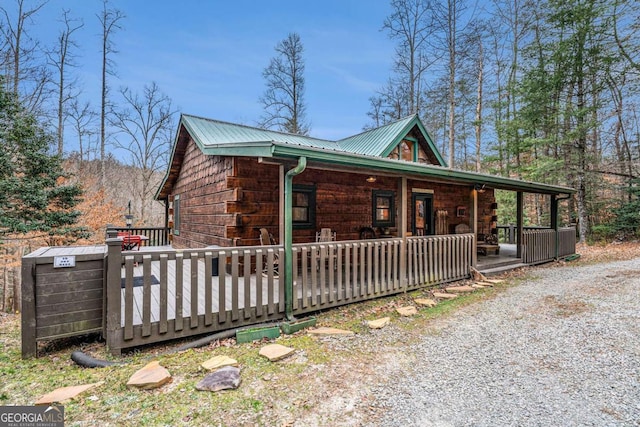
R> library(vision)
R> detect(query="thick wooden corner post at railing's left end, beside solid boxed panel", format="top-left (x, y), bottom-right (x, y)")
top-left (103, 238), bottom-right (122, 355)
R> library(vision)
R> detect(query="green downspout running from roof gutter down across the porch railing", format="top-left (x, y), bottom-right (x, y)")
top-left (280, 157), bottom-right (307, 320)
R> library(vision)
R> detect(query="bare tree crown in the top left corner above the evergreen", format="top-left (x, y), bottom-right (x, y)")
top-left (0, 0), bottom-right (50, 113)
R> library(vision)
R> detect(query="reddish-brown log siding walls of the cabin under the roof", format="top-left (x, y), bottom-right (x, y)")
top-left (173, 152), bottom-right (495, 248)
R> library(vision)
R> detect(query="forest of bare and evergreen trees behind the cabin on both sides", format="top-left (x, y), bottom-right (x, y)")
top-left (0, 0), bottom-right (640, 310)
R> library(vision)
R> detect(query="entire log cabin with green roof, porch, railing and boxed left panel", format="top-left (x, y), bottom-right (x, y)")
top-left (22, 115), bottom-right (576, 357)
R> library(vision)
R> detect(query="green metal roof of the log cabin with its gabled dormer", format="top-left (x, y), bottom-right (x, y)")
top-left (156, 115), bottom-right (575, 198)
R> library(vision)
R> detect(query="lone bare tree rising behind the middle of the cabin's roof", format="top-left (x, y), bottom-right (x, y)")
top-left (259, 33), bottom-right (310, 135)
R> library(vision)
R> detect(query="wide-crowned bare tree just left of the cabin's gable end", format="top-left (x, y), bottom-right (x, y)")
top-left (109, 82), bottom-right (175, 221)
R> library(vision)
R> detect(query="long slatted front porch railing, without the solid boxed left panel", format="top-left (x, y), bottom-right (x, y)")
top-left (105, 234), bottom-right (474, 354)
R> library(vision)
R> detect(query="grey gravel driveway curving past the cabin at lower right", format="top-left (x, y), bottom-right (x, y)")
top-left (358, 259), bottom-right (640, 427)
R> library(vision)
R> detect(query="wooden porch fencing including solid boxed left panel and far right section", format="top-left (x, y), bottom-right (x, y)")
top-left (22, 228), bottom-right (576, 357)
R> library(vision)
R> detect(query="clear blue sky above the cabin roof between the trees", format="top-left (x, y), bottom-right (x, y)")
top-left (29, 0), bottom-right (394, 145)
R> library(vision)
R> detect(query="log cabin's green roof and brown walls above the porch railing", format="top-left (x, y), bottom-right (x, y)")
top-left (156, 114), bottom-right (574, 254)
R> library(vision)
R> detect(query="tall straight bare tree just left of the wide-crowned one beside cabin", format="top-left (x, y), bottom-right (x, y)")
top-left (97, 0), bottom-right (125, 188)
